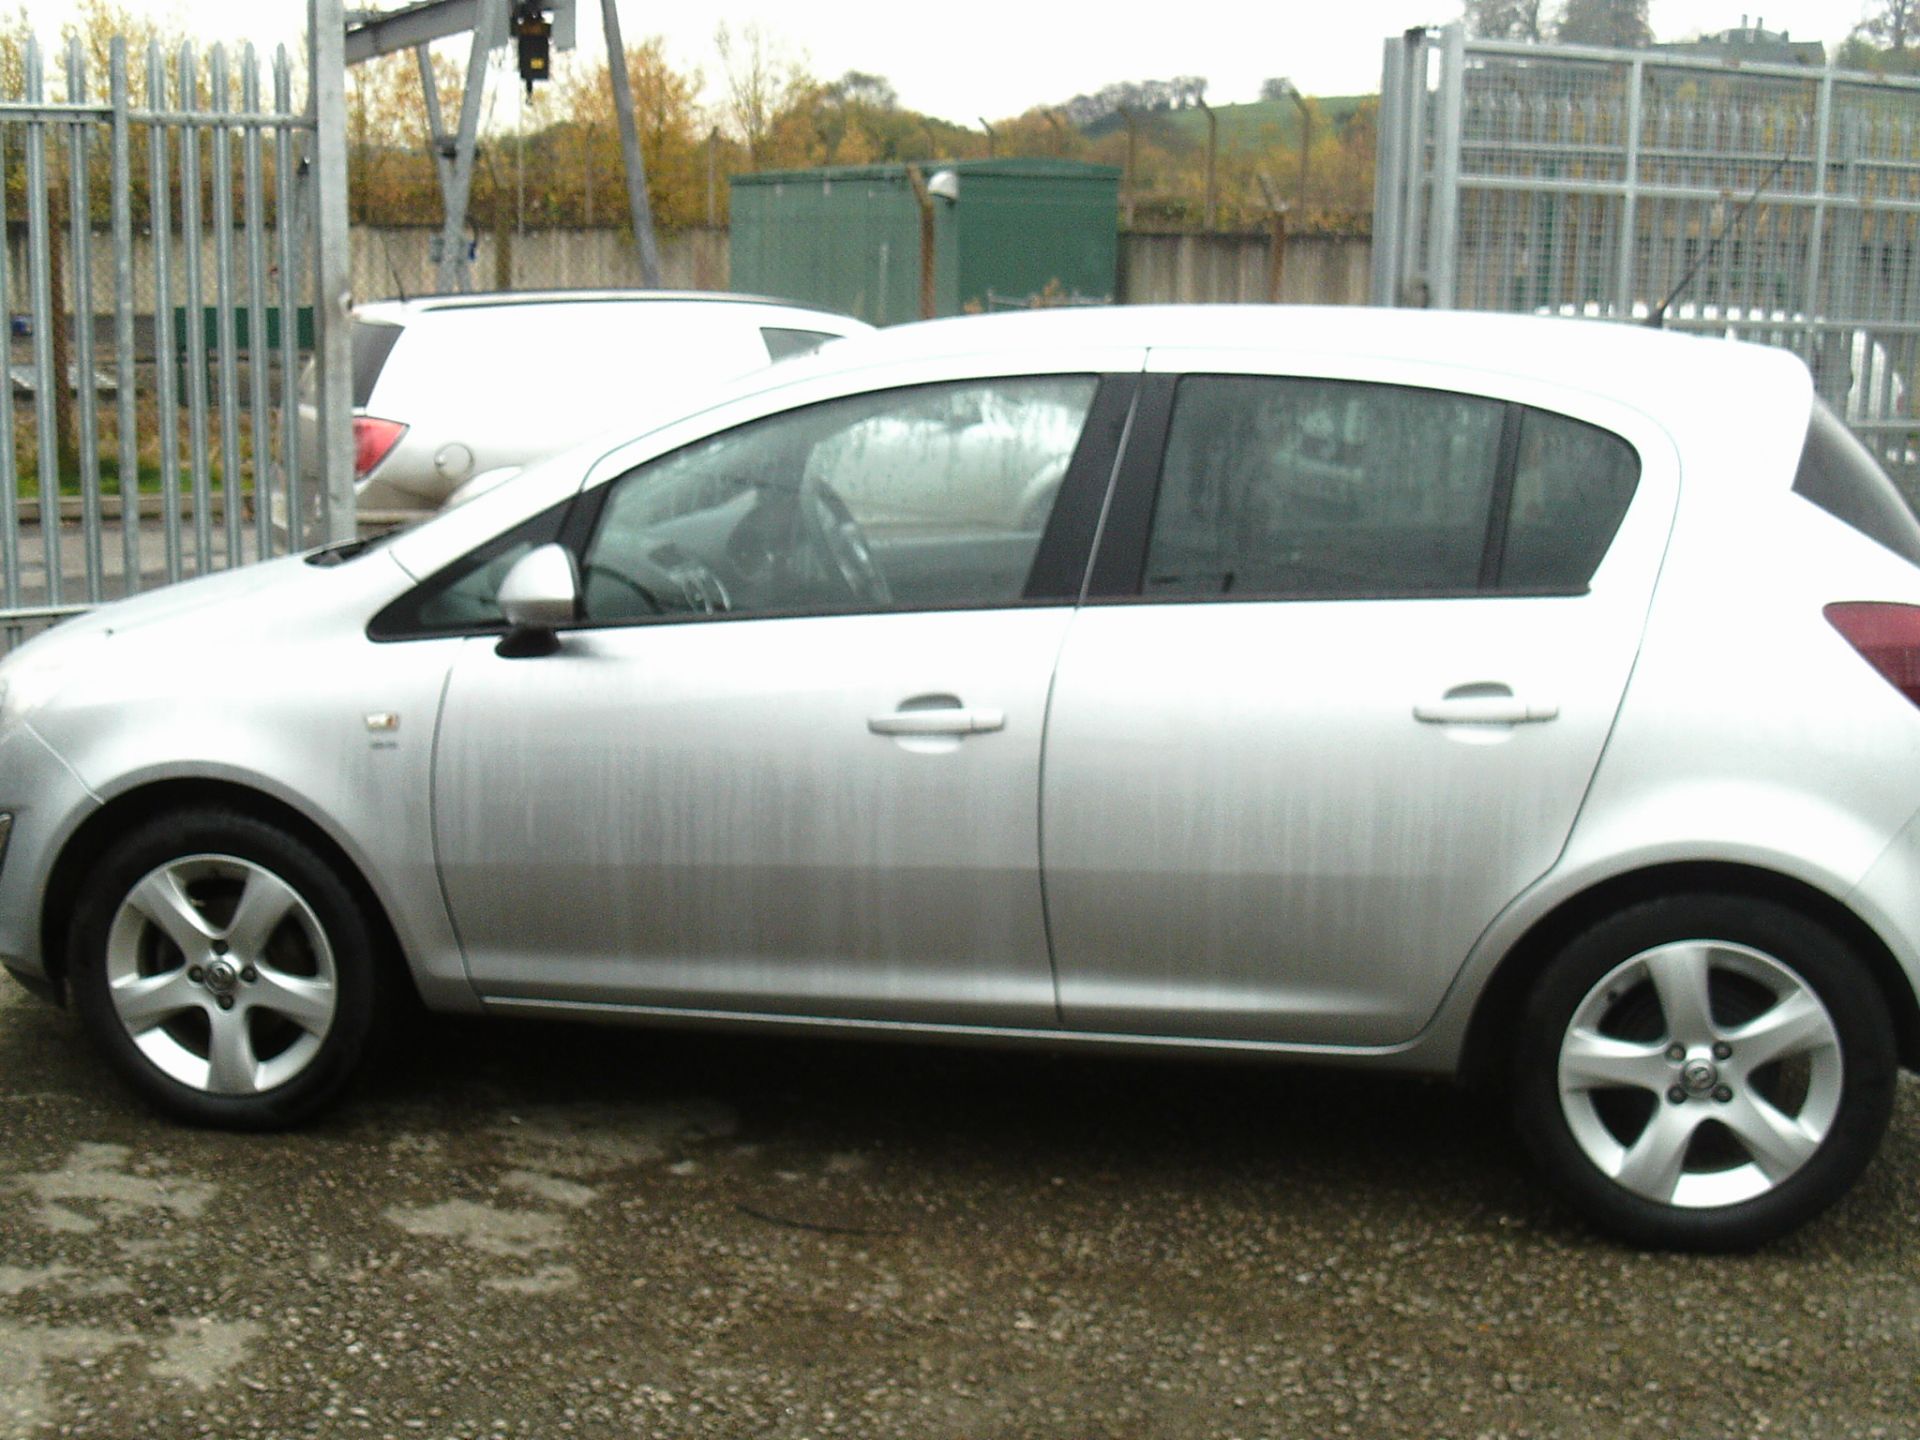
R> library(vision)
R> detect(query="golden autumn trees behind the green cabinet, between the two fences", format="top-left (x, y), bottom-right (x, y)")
top-left (337, 25), bottom-right (1373, 232)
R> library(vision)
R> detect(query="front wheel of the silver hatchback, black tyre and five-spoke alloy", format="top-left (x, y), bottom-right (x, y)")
top-left (67, 810), bottom-right (386, 1129)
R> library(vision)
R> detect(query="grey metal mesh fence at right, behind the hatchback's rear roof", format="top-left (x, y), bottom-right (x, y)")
top-left (1373, 25), bottom-right (1920, 497)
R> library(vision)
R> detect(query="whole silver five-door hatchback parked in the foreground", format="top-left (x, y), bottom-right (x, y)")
top-left (0, 307), bottom-right (1920, 1248)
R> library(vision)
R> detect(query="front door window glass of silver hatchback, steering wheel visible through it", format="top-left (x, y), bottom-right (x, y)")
top-left (582, 376), bottom-right (1098, 624)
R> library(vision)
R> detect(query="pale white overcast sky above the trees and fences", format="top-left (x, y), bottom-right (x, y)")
top-left (15, 0), bottom-right (1872, 125)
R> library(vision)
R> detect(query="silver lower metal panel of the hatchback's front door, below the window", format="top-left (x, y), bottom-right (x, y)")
top-left (434, 607), bottom-right (1071, 1025)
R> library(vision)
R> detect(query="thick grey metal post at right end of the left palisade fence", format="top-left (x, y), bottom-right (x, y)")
top-left (307, 0), bottom-right (355, 541)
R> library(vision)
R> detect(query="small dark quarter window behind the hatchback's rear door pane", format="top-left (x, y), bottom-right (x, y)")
top-left (1500, 409), bottom-right (1640, 589)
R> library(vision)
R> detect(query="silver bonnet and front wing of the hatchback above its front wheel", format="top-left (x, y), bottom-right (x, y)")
top-left (0, 555), bottom-right (474, 1008)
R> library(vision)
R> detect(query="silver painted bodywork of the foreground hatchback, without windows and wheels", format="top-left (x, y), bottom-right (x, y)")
top-left (0, 307), bottom-right (1920, 1069)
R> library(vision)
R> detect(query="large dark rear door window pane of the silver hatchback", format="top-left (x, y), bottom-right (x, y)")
top-left (1146, 376), bottom-right (1505, 597)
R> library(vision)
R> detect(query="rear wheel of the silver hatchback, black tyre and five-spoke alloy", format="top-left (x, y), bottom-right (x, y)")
top-left (1513, 895), bottom-right (1897, 1250)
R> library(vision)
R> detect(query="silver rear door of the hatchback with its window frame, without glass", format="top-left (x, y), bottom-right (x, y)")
top-left (1043, 349), bottom-right (1680, 1046)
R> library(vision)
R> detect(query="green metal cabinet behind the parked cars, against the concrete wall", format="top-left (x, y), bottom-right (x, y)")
top-left (730, 159), bottom-right (1119, 324)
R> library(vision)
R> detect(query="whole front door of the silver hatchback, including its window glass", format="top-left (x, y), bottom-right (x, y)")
top-left (434, 374), bottom-right (1110, 1025)
